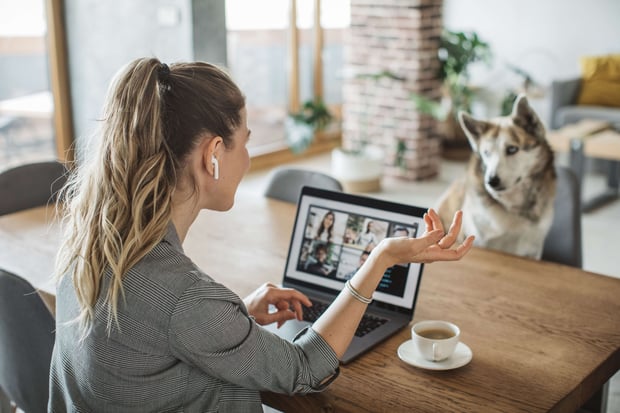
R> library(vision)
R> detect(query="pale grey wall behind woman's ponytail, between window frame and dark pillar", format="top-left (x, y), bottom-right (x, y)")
top-left (65, 0), bottom-right (193, 158)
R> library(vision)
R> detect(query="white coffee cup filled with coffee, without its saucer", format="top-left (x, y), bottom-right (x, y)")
top-left (411, 320), bottom-right (461, 361)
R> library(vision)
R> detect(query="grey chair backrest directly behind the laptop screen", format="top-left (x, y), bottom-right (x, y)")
top-left (265, 167), bottom-right (342, 204)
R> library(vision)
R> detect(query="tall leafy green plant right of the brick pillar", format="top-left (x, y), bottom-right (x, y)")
top-left (410, 30), bottom-right (492, 157)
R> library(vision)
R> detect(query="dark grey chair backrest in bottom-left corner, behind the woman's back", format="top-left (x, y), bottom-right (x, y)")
top-left (0, 270), bottom-right (55, 413)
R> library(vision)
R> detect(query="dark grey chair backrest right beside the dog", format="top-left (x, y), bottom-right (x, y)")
top-left (542, 166), bottom-right (582, 268)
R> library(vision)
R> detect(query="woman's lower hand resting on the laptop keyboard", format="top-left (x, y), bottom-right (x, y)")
top-left (243, 283), bottom-right (312, 327)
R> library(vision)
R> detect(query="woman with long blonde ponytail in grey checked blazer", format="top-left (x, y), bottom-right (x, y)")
top-left (49, 58), bottom-right (472, 412)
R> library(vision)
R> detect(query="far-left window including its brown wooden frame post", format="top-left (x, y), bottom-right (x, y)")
top-left (0, 0), bottom-right (73, 169)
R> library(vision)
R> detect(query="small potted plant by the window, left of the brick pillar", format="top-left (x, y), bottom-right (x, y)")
top-left (285, 98), bottom-right (333, 154)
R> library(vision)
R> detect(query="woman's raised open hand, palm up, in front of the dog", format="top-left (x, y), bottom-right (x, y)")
top-left (381, 209), bottom-right (474, 266)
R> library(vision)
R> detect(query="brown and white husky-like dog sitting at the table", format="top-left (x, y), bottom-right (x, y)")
top-left (437, 95), bottom-right (556, 259)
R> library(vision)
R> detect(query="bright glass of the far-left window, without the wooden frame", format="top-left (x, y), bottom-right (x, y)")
top-left (0, 0), bottom-right (56, 169)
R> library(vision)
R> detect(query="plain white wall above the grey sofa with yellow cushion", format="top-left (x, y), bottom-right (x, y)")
top-left (444, 0), bottom-right (620, 124)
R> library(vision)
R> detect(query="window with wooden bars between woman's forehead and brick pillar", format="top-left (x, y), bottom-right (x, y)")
top-left (226, 0), bottom-right (350, 159)
